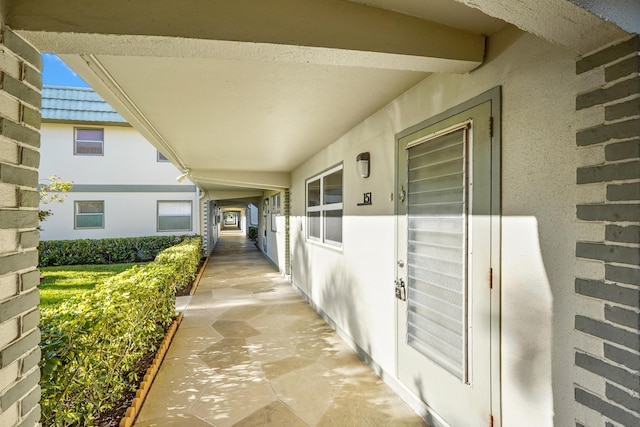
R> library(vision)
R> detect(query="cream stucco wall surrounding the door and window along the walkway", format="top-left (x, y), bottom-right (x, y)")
top-left (291, 27), bottom-right (604, 426)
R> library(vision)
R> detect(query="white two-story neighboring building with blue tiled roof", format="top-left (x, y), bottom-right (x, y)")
top-left (40, 86), bottom-right (200, 240)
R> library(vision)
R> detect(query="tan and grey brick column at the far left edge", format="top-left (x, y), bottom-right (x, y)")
top-left (0, 27), bottom-right (42, 426)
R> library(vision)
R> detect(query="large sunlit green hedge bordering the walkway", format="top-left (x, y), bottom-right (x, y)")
top-left (40, 237), bottom-right (202, 426)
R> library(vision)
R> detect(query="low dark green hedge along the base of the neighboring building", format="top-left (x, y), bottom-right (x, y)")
top-left (38, 236), bottom-right (195, 267)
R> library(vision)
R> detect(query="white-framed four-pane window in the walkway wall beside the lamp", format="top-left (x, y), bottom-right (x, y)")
top-left (307, 165), bottom-right (342, 246)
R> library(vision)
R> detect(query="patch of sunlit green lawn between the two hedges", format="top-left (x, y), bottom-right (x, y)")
top-left (39, 263), bottom-right (139, 307)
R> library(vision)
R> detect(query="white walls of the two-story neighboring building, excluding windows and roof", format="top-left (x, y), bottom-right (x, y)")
top-left (39, 123), bottom-right (201, 240)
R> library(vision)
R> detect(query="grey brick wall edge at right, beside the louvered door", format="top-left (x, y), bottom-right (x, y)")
top-left (574, 36), bottom-right (640, 427)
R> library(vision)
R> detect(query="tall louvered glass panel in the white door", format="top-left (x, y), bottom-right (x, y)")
top-left (407, 128), bottom-right (468, 382)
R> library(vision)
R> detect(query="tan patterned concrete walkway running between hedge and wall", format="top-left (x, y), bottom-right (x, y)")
top-left (135, 233), bottom-right (425, 427)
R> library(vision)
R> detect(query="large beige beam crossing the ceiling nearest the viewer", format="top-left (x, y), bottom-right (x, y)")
top-left (8, 0), bottom-right (484, 72)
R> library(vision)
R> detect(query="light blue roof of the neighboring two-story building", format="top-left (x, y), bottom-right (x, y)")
top-left (40, 85), bottom-right (127, 123)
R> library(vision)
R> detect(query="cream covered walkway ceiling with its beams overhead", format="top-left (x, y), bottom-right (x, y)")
top-left (6, 0), bottom-right (628, 201)
